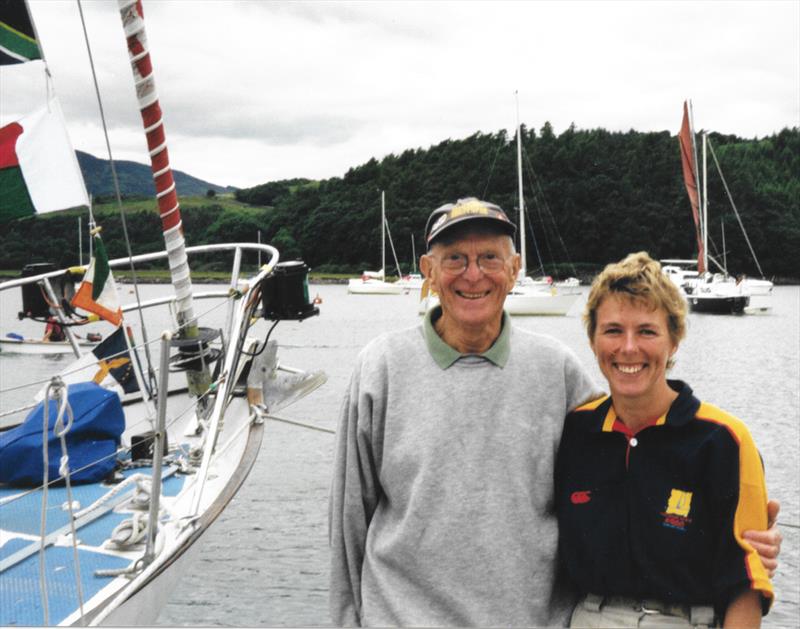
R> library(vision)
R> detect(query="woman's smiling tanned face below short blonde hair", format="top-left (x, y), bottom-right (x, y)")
top-left (591, 294), bottom-right (678, 407)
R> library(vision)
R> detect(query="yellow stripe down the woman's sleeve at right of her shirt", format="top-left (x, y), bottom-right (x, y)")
top-left (697, 402), bottom-right (774, 601)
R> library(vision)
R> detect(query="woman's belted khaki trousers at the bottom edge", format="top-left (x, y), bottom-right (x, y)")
top-left (570, 594), bottom-right (717, 629)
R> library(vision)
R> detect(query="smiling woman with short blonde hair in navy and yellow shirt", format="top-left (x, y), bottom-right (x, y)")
top-left (556, 252), bottom-right (773, 627)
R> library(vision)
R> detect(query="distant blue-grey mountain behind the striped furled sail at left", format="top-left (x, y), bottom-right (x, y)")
top-left (75, 151), bottom-right (235, 197)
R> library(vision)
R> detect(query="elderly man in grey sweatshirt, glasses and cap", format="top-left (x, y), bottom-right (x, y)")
top-left (330, 198), bottom-right (774, 626)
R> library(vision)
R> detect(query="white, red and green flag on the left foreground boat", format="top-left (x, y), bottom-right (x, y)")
top-left (0, 98), bottom-right (89, 222)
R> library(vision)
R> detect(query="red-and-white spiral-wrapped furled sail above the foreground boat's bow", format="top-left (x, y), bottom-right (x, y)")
top-left (117, 0), bottom-right (211, 397)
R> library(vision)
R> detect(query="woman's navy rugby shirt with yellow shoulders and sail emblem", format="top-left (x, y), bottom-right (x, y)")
top-left (556, 381), bottom-right (773, 614)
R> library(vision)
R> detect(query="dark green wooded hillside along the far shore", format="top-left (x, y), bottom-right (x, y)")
top-left (0, 123), bottom-right (800, 278)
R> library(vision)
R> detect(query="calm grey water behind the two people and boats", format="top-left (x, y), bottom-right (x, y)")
top-left (0, 285), bottom-right (800, 627)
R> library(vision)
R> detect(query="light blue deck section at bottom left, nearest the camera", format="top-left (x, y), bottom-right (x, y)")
top-left (0, 540), bottom-right (130, 626)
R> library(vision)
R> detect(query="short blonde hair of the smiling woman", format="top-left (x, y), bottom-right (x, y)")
top-left (583, 251), bottom-right (686, 346)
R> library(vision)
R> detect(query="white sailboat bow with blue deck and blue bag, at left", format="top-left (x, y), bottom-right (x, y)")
top-left (0, 0), bottom-right (324, 626)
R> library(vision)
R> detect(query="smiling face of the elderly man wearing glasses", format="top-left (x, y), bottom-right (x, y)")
top-left (420, 233), bottom-right (520, 331)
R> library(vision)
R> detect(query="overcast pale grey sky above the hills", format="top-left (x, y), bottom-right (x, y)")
top-left (0, 0), bottom-right (800, 187)
